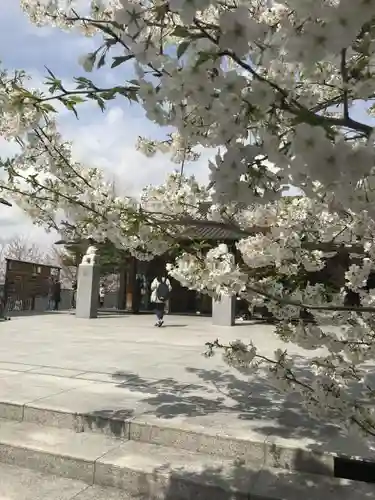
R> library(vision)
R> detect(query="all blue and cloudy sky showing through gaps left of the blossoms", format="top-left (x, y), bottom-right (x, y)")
top-left (0, 0), bottom-right (212, 243)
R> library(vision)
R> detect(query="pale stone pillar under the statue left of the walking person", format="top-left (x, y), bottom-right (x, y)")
top-left (76, 262), bottom-right (100, 319)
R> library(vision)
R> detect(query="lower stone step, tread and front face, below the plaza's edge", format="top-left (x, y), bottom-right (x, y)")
top-left (0, 420), bottom-right (375, 500)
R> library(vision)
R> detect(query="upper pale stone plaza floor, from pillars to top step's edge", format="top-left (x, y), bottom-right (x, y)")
top-left (0, 313), bottom-right (373, 456)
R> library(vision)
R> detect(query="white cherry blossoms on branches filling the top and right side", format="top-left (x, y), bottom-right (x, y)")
top-left (5, 0), bottom-right (375, 434)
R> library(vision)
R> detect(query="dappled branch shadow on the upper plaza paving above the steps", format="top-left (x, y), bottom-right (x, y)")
top-left (81, 363), bottom-right (375, 470)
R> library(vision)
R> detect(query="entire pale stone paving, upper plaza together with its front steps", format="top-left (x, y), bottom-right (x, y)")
top-left (0, 313), bottom-right (375, 500)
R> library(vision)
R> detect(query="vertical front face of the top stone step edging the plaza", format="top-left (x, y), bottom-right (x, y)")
top-left (0, 398), bottom-right (358, 477)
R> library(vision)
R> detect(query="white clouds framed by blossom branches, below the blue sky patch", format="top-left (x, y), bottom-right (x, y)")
top-left (0, 100), bottom-right (210, 240)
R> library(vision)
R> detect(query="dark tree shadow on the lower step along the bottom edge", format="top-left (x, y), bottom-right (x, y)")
top-left (101, 457), bottom-right (375, 500)
